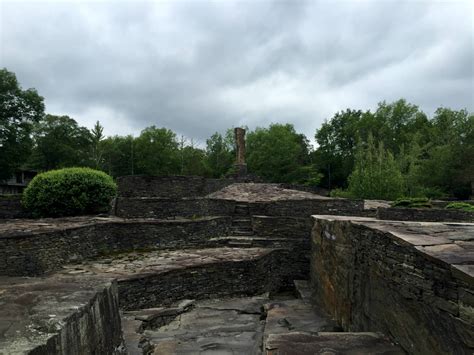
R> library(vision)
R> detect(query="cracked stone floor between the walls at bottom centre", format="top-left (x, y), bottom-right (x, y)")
top-left (122, 284), bottom-right (403, 355)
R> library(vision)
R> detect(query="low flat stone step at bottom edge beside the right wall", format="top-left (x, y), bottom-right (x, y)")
top-left (265, 332), bottom-right (405, 355)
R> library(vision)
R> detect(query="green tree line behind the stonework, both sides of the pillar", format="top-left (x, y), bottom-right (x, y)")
top-left (0, 69), bottom-right (474, 198)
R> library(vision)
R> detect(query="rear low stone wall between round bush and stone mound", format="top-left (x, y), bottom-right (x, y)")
top-left (117, 175), bottom-right (241, 198)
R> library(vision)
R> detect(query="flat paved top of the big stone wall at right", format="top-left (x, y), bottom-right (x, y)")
top-left (313, 215), bottom-right (474, 283)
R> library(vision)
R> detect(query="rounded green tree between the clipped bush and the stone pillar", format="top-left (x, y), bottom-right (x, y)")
top-left (134, 126), bottom-right (180, 175)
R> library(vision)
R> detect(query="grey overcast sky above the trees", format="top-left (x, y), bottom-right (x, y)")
top-left (0, 0), bottom-right (474, 143)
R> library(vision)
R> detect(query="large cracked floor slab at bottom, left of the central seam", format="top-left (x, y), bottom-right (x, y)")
top-left (144, 296), bottom-right (268, 355)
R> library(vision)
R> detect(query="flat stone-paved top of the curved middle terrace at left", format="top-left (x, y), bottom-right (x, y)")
top-left (59, 248), bottom-right (274, 281)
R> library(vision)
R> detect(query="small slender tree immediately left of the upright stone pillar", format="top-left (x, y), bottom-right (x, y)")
top-left (206, 132), bottom-right (235, 178)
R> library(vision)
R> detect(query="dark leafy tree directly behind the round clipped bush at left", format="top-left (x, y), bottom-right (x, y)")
top-left (30, 115), bottom-right (92, 170)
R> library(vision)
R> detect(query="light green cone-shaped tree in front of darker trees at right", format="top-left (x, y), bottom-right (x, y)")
top-left (348, 134), bottom-right (403, 200)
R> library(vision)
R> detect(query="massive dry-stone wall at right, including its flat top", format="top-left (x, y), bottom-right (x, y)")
top-left (310, 216), bottom-right (474, 354)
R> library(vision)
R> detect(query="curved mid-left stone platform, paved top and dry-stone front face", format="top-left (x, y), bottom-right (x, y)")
top-left (60, 248), bottom-right (292, 309)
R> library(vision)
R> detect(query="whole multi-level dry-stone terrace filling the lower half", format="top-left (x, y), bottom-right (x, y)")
top-left (0, 177), bottom-right (474, 355)
